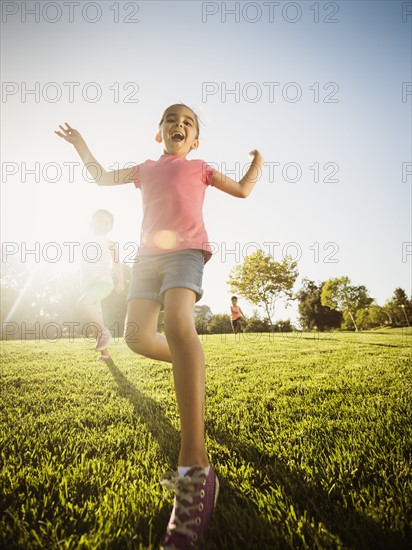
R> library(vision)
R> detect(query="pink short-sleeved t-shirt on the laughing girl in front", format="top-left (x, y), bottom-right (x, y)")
top-left (133, 155), bottom-right (215, 261)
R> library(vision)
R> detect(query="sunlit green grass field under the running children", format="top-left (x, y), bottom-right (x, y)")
top-left (0, 329), bottom-right (412, 550)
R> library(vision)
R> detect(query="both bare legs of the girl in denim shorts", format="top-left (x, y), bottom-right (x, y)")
top-left (125, 296), bottom-right (209, 467)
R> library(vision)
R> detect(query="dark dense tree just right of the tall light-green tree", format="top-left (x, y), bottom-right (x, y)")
top-left (297, 279), bottom-right (342, 332)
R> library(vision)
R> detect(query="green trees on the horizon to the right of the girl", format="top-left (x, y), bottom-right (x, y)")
top-left (228, 250), bottom-right (412, 331)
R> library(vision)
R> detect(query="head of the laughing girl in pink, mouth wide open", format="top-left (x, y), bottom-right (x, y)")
top-left (156, 105), bottom-right (199, 157)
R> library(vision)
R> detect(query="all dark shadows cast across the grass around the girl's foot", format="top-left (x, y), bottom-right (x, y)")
top-left (107, 361), bottom-right (408, 550)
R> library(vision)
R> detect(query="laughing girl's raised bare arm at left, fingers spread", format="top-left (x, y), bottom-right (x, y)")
top-left (55, 122), bottom-right (133, 185)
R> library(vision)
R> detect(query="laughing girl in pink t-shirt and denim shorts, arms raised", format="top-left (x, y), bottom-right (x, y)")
top-left (56, 104), bottom-right (263, 550)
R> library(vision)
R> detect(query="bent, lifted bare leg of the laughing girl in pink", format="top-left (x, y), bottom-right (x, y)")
top-left (124, 298), bottom-right (172, 363)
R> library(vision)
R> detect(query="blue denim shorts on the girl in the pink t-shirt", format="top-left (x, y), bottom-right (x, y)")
top-left (127, 250), bottom-right (204, 305)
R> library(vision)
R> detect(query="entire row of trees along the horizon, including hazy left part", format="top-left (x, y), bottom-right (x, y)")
top-left (0, 250), bottom-right (412, 339)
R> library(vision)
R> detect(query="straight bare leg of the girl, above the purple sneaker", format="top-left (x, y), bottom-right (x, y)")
top-left (165, 288), bottom-right (209, 467)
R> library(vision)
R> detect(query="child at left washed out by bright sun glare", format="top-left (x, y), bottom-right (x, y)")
top-left (78, 210), bottom-right (124, 361)
